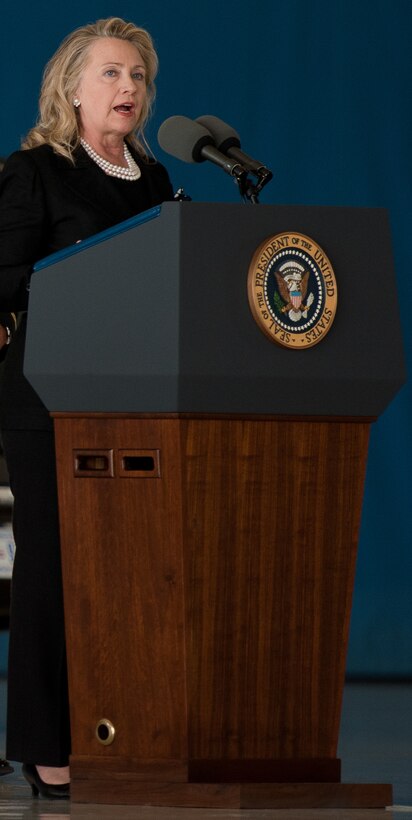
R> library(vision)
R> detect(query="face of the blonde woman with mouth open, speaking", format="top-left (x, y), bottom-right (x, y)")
top-left (76, 37), bottom-right (146, 145)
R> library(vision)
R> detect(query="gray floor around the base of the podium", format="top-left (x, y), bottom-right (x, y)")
top-left (0, 680), bottom-right (412, 820)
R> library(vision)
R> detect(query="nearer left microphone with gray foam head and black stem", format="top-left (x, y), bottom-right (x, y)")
top-left (157, 115), bottom-right (247, 179)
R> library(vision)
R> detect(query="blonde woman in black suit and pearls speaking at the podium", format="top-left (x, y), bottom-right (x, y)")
top-left (0, 18), bottom-right (173, 798)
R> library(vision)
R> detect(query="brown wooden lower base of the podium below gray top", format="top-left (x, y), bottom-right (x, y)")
top-left (55, 415), bottom-right (391, 808)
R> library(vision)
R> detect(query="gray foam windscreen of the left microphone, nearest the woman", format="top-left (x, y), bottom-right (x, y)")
top-left (157, 115), bottom-right (214, 162)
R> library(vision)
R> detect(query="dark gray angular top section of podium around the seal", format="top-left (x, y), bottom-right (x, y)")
top-left (25, 202), bottom-right (405, 417)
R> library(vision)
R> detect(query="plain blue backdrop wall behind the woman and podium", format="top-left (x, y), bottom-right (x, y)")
top-left (0, 0), bottom-right (412, 677)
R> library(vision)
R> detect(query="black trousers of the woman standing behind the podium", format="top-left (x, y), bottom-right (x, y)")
top-left (2, 430), bottom-right (70, 766)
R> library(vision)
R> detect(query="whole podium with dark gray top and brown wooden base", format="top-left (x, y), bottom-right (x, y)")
top-left (25, 203), bottom-right (405, 809)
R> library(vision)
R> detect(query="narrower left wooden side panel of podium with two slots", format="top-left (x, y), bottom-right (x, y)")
top-left (56, 420), bottom-right (186, 758)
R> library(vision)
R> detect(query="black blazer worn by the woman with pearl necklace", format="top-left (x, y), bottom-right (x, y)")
top-left (0, 145), bottom-right (173, 429)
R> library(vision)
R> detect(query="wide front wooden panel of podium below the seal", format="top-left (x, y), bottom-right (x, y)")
top-left (183, 420), bottom-right (368, 758)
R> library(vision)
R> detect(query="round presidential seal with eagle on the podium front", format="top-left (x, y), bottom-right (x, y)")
top-left (248, 232), bottom-right (337, 350)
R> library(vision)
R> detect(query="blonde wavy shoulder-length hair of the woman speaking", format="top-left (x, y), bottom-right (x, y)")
top-left (22, 17), bottom-right (158, 162)
